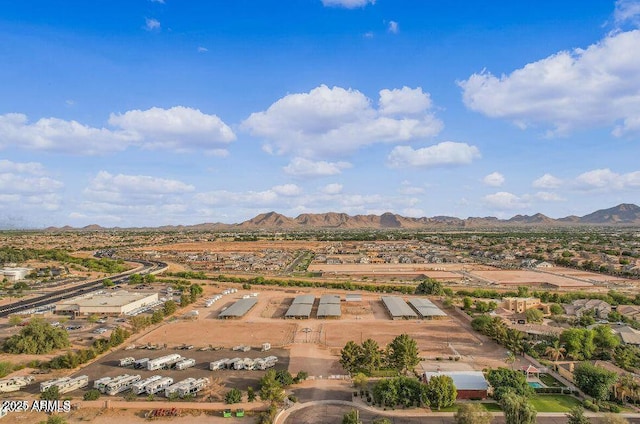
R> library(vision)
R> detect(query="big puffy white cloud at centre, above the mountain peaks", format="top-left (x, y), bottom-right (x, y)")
top-left (243, 85), bottom-right (442, 158)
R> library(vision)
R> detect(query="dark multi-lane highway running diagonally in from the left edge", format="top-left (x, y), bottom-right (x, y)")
top-left (0, 259), bottom-right (167, 317)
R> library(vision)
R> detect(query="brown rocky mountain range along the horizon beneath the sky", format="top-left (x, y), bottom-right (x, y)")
top-left (41, 203), bottom-right (640, 231)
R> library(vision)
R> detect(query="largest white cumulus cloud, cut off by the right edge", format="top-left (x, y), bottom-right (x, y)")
top-left (459, 30), bottom-right (640, 136)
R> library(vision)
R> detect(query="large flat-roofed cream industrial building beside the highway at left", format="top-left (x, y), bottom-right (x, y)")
top-left (55, 290), bottom-right (158, 316)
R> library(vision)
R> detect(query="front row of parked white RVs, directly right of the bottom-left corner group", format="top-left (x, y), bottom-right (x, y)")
top-left (93, 374), bottom-right (209, 398)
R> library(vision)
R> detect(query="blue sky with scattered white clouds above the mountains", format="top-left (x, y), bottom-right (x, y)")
top-left (0, 0), bottom-right (640, 228)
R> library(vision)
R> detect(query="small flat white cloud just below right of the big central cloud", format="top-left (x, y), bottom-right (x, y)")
top-left (387, 141), bottom-right (480, 168)
